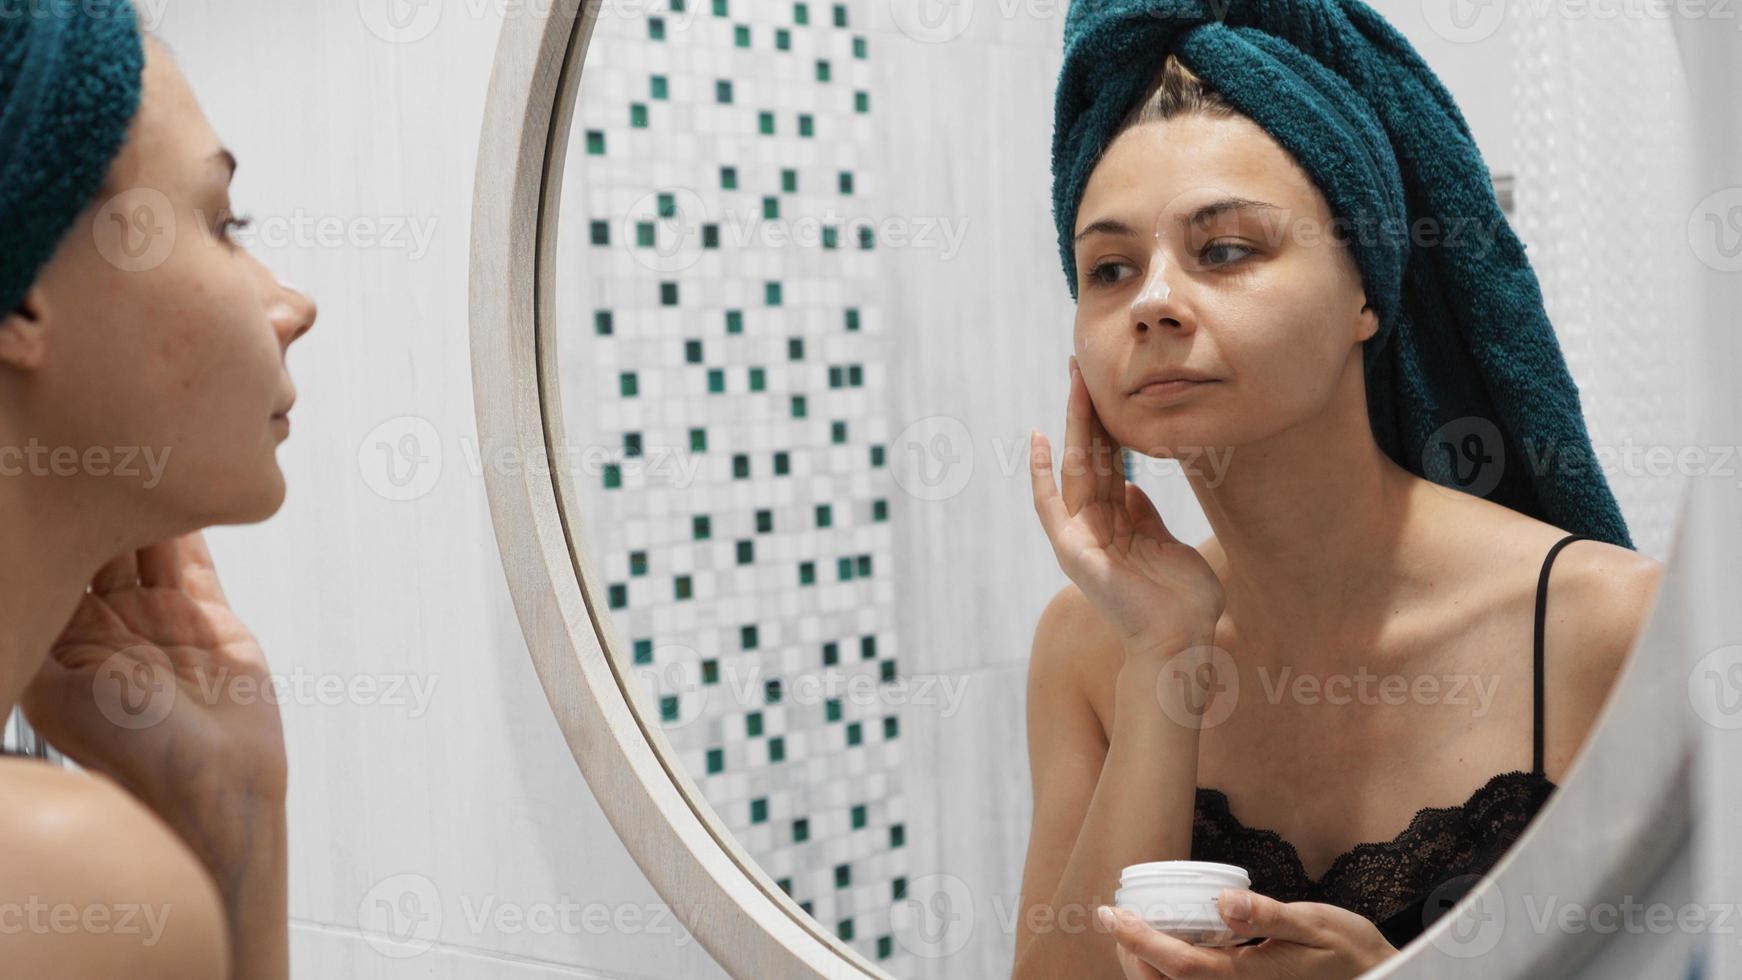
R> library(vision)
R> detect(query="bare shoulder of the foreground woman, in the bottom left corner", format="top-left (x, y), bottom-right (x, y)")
top-left (0, 759), bottom-right (228, 980)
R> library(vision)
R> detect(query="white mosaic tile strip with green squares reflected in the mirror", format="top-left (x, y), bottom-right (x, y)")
top-left (557, 0), bottom-right (908, 975)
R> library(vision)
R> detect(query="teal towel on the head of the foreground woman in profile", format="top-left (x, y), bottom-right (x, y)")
top-left (0, 0), bottom-right (145, 310)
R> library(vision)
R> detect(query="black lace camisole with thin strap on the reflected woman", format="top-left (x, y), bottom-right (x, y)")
top-left (1192, 534), bottom-right (1587, 949)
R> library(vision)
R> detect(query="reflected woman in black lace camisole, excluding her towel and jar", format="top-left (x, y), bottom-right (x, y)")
top-left (1016, 56), bottom-right (1662, 980)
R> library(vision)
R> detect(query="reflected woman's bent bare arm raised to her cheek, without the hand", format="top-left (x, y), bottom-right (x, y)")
top-left (1012, 587), bottom-right (1211, 980)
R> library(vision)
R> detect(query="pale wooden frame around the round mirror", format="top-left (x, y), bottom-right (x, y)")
top-left (470, 0), bottom-right (1693, 980)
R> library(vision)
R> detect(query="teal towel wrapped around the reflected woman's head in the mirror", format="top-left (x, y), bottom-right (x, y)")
top-left (1052, 0), bottom-right (1634, 548)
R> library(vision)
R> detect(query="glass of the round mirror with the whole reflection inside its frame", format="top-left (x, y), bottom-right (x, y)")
top-left (547, 0), bottom-right (1691, 978)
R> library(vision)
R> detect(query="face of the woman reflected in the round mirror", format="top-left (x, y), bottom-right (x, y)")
top-left (1075, 115), bottom-right (1378, 456)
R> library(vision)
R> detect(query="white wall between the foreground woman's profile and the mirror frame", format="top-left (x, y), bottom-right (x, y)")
top-left (162, 0), bottom-right (718, 980)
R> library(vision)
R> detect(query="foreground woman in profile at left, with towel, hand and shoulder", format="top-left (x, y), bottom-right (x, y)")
top-left (0, 0), bottom-right (315, 980)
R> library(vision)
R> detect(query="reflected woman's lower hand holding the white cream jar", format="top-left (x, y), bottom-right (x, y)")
top-left (1113, 889), bottom-right (1397, 980)
